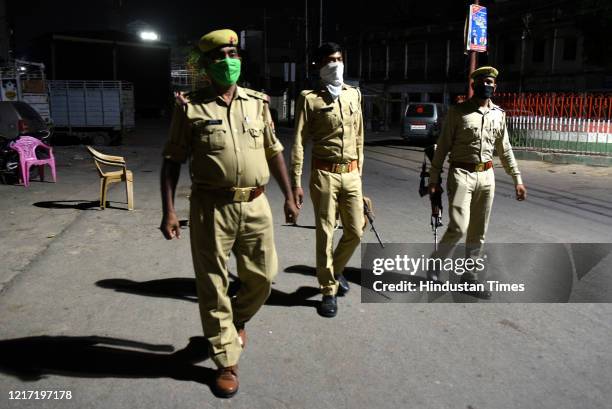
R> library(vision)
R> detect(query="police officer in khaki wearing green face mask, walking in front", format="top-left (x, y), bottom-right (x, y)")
top-left (160, 30), bottom-right (298, 397)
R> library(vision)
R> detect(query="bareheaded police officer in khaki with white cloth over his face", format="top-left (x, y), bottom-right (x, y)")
top-left (291, 43), bottom-right (364, 317)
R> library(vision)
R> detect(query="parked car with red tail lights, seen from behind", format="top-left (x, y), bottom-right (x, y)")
top-left (402, 102), bottom-right (447, 143)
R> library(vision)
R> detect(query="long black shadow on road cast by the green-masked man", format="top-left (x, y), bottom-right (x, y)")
top-left (0, 335), bottom-right (216, 391)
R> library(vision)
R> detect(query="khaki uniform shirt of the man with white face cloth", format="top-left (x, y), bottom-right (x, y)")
top-left (291, 85), bottom-right (364, 187)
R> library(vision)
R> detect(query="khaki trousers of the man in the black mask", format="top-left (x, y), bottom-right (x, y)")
top-left (436, 168), bottom-right (495, 280)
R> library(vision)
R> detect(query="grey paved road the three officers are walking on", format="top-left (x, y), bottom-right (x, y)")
top-left (0, 122), bottom-right (612, 409)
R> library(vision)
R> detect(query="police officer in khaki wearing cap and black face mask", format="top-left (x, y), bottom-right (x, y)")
top-left (429, 66), bottom-right (527, 298)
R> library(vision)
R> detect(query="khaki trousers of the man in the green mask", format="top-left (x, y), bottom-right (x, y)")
top-left (190, 190), bottom-right (278, 367)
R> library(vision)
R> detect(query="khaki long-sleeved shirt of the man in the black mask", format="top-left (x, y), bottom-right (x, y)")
top-left (429, 100), bottom-right (523, 185)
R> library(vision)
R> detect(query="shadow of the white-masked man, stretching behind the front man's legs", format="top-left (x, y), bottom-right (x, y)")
top-left (96, 275), bottom-right (320, 307)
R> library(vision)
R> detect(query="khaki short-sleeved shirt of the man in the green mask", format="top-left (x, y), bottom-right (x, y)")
top-left (163, 87), bottom-right (283, 189)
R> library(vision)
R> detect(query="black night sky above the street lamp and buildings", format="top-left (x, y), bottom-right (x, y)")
top-left (8, 0), bottom-right (468, 50)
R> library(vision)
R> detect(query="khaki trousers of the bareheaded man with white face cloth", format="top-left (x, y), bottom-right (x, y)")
top-left (310, 168), bottom-right (364, 295)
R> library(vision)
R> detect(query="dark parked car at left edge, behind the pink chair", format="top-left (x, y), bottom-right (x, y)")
top-left (0, 101), bottom-right (52, 141)
